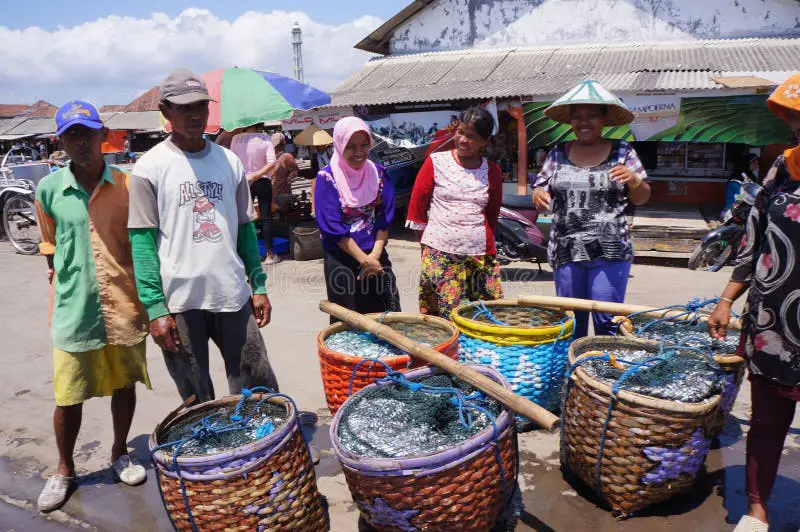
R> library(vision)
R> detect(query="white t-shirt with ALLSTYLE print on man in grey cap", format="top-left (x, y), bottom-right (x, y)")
top-left (128, 139), bottom-right (256, 313)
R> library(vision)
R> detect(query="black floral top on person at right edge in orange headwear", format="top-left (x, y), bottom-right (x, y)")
top-left (731, 155), bottom-right (800, 387)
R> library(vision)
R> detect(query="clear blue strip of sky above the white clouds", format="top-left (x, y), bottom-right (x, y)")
top-left (0, 0), bottom-right (404, 30)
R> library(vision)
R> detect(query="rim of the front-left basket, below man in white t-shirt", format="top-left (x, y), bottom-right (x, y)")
top-left (148, 393), bottom-right (297, 470)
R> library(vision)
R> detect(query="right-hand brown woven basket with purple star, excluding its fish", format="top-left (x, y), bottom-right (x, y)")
top-left (561, 337), bottom-right (720, 517)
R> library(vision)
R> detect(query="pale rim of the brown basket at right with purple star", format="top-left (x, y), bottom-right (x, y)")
top-left (569, 336), bottom-right (720, 414)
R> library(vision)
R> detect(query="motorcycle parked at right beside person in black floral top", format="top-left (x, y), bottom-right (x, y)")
top-left (689, 183), bottom-right (761, 272)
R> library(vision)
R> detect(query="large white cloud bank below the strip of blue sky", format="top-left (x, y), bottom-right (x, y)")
top-left (0, 9), bottom-right (382, 105)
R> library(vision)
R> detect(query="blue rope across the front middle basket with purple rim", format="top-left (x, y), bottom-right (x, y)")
top-left (347, 358), bottom-right (514, 504)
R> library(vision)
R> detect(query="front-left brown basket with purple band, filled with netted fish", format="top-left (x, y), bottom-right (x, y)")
top-left (149, 389), bottom-right (329, 532)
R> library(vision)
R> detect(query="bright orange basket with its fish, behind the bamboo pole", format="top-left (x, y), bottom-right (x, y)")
top-left (317, 312), bottom-right (458, 414)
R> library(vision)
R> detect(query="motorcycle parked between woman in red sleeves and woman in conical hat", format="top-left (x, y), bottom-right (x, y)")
top-left (494, 194), bottom-right (547, 271)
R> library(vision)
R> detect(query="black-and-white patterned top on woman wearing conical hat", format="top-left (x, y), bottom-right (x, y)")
top-left (533, 141), bottom-right (647, 270)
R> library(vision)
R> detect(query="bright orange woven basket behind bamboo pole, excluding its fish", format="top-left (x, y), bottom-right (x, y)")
top-left (317, 312), bottom-right (458, 414)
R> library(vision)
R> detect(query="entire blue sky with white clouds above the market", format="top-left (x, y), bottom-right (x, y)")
top-left (0, 0), bottom-right (410, 105)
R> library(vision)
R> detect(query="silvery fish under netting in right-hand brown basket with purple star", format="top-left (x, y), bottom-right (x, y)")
top-left (581, 348), bottom-right (726, 403)
